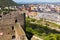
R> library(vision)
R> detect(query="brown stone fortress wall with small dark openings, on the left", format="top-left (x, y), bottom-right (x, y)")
top-left (0, 11), bottom-right (24, 40)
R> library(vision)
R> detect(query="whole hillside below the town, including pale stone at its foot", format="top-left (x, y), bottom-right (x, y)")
top-left (26, 17), bottom-right (60, 40)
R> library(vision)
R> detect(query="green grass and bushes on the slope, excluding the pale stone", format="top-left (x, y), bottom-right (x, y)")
top-left (26, 18), bottom-right (60, 40)
